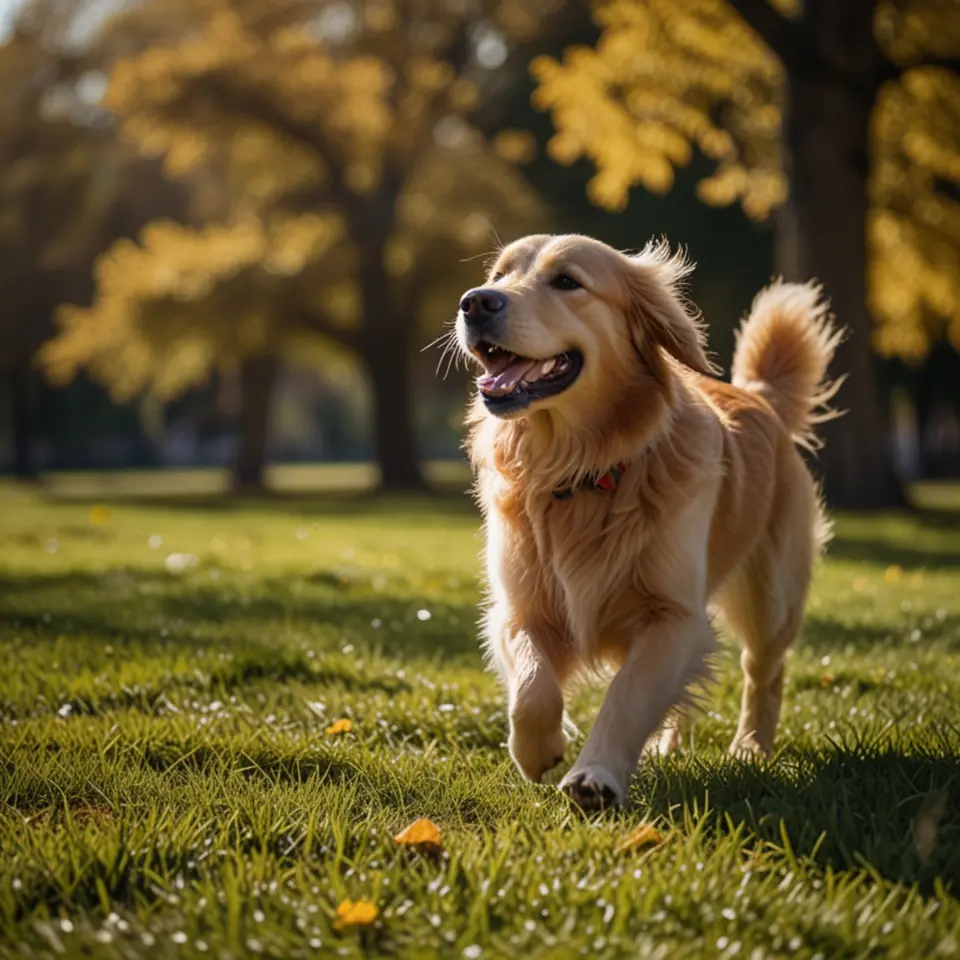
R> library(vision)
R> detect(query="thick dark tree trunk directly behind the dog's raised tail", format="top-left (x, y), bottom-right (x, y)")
top-left (777, 64), bottom-right (905, 510)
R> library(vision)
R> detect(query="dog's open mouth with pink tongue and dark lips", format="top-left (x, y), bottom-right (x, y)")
top-left (474, 340), bottom-right (583, 413)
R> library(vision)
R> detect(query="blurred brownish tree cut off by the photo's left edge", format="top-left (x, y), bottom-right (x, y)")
top-left (0, 0), bottom-right (186, 477)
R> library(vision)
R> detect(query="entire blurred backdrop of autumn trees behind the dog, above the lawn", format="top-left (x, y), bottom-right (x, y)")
top-left (0, 0), bottom-right (960, 506)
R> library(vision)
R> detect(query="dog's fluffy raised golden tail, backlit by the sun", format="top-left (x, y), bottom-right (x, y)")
top-left (733, 281), bottom-right (844, 449)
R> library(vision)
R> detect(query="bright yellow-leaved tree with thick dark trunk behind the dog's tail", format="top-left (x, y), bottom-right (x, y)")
top-left (534, 0), bottom-right (960, 507)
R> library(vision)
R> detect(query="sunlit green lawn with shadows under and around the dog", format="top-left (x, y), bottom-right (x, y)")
top-left (0, 477), bottom-right (960, 958)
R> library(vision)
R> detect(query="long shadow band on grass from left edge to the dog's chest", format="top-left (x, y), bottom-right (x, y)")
top-left (0, 569), bottom-right (479, 660)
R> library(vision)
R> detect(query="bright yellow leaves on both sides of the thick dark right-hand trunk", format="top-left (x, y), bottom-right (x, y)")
top-left (531, 0), bottom-right (960, 358)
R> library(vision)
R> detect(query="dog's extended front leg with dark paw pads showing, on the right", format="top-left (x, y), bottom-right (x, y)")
top-left (560, 614), bottom-right (716, 810)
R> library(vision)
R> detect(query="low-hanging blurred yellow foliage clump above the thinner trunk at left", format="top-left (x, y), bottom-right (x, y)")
top-left (40, 214), bottom-right (343, 400)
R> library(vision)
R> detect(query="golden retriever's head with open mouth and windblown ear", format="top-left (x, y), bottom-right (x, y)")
top-left (457, 235), bottom-right (713, 419)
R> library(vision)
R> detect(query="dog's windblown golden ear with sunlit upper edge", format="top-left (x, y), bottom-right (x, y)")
top-left (626, 242), bottom-right (718, 380)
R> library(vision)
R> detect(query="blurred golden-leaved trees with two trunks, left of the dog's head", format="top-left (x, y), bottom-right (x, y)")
top-left (43, 0), bottom-right (550, 489)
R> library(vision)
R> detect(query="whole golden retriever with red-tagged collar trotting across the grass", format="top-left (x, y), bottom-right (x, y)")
top-left (456, 235), bottom-right (839, 809)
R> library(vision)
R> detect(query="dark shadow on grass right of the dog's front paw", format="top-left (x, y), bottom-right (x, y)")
top-left (635, 744), bottom-right (960, 893)
